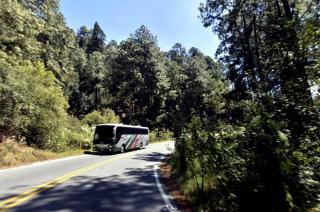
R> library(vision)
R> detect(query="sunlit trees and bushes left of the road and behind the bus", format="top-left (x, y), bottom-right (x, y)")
top-left (0, 0), bottom-right (221, 151)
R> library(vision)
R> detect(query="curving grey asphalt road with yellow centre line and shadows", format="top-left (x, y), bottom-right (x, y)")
top-left (0, 142), bottom-right (174, 211)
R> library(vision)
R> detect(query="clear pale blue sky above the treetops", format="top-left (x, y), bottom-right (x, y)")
top-left (60, 0), bottom-right (219, 57)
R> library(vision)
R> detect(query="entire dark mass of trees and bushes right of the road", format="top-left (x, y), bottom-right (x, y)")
top-left (173, 0), bottom-right (320, 211)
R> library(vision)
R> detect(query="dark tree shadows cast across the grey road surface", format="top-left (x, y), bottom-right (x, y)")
top-left (12, 152), bottom-right (167, 211)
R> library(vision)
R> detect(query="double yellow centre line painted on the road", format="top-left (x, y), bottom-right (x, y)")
top-left (0, 148), bottom-right (147, 211)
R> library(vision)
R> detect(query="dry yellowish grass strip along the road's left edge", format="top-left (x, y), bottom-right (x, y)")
top-left (0, 140), bottom-right (83, 169)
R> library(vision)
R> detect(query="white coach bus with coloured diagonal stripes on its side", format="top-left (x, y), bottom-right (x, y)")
top-left (93, 124), bottom-right (149, 153)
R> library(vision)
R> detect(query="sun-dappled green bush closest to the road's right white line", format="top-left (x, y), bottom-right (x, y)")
top-left (171, 117), bottom-right (246, 211)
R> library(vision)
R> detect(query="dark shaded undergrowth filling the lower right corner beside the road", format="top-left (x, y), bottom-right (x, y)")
top-left (171, 113), bottom-right (320, 211)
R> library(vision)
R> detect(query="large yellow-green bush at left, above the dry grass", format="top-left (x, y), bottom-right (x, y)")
top-left (0, 58), bottom-right (90, 151)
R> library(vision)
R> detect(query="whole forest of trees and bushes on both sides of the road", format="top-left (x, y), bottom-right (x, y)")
top-left (0, 0), bottom-right (320, 211)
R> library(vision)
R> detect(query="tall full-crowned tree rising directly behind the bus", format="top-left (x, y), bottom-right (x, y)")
top-left (110, 26), bottom-right (167, 126)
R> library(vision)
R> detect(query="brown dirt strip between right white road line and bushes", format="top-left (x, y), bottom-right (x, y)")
top-left (160, 158), bottom-right (197, 212)
